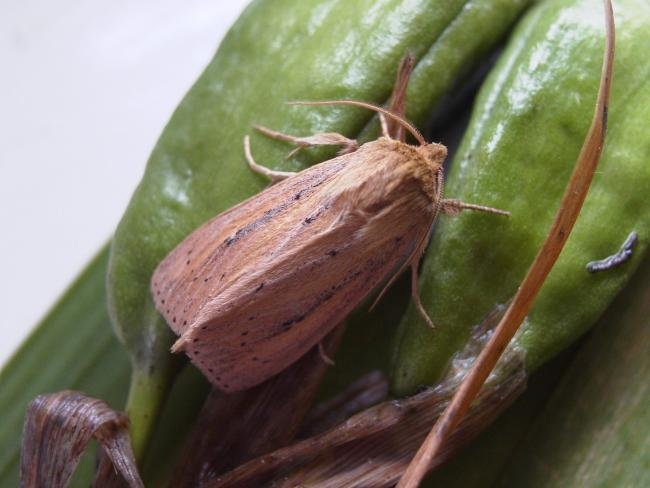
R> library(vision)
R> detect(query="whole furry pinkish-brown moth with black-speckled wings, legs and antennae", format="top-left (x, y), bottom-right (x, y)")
top-left (151, 56), bottom-right (508, 392)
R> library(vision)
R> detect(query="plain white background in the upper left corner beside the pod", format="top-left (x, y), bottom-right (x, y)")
top-left (0, 0), bottom-right (247, 366)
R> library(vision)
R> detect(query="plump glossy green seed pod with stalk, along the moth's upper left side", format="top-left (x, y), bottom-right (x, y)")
top-left (109, 0), bottom-right (528, 457)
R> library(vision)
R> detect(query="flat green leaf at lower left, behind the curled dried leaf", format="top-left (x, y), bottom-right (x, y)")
top-left (0, 246), bottom-right (129, 488)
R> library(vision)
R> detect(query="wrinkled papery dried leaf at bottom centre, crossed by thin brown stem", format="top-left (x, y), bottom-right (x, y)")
top-left (205, 340), bottom-right (526, 488)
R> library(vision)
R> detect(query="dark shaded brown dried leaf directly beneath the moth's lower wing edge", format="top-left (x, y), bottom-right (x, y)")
top-left (170, 324), bottom-right (345, 487)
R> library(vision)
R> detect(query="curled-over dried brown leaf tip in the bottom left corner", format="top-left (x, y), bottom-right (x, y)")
top-left (20, 390), bottom-right (144, 488)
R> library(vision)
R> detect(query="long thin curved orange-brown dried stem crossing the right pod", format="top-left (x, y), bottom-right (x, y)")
top-left (398, 0), bottom-right (615, 488)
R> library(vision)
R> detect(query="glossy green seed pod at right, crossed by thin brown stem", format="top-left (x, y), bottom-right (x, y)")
top-left (393, 0), bottom-right (650, 394)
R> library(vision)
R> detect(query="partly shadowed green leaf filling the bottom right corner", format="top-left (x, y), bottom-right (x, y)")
top-left (416, 250), bottom-right (650, 488)
